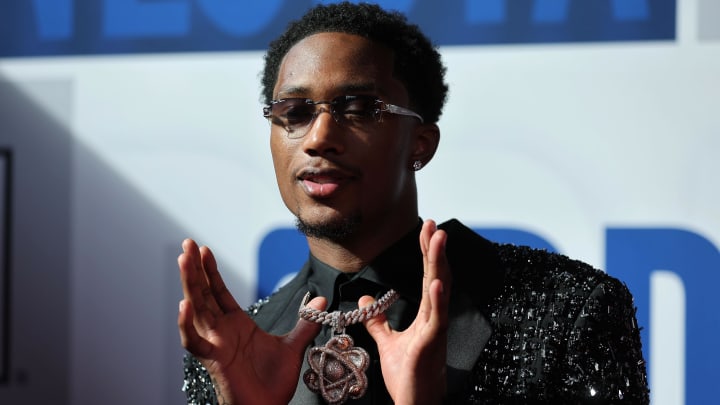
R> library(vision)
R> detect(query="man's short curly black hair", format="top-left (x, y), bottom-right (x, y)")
top-left (262, 2), bottom-right (448, 123)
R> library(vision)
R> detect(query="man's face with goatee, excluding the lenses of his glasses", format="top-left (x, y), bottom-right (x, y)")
top-left (270, 33), bottom-right (428, 239)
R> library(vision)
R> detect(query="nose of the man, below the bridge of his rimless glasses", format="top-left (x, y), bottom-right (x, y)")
top-left (301, 107), bottom-right (347, 156)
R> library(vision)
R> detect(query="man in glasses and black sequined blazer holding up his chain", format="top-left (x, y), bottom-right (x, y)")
top-left (178, 3), bottom-right (648, 404)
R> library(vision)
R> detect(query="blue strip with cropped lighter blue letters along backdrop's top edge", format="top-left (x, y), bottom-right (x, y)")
top-left (0, 0), bottom-right (676, 57)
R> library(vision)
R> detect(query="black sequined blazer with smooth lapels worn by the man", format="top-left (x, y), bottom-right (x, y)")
top-left (184, 220), bottom-right (649, 405)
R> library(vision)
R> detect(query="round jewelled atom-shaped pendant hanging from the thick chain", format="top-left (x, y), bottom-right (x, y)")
top-left (303, 333), bottom-right (370, 405)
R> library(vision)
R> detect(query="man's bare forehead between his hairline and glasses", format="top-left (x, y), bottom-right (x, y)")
top-left (273, 32), bottom-right (405, 101)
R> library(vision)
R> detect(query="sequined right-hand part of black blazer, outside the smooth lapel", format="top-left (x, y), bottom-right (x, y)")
top-left (476, 244), bottom-right (647, 403)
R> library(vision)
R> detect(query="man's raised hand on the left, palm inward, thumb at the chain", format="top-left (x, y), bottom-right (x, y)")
top-left (178, 239), bottom-right (327, 405)
